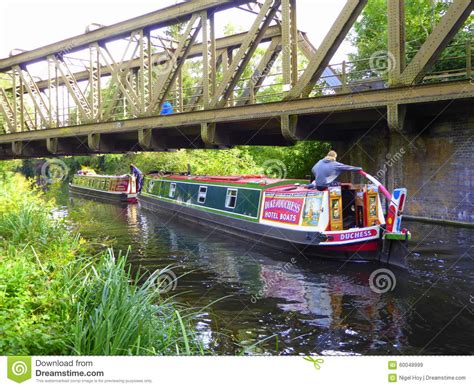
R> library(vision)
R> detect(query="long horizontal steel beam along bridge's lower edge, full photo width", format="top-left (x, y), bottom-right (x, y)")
top-left (0, 81), bottom-right (474, 144)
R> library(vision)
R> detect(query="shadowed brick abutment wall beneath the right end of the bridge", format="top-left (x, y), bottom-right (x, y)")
top-left (334, 113), bottom-right (474, 223)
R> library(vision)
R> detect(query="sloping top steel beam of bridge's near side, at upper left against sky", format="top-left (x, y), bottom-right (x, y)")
top-left (0, 0), bottom-right (252, 72)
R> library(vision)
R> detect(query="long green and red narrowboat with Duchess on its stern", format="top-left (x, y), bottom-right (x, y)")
top-left (139, 172), bottom-right (410, 265)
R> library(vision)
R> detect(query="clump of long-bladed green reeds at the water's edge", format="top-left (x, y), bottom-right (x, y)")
top-left (69, 250), bottom-right (202, 355)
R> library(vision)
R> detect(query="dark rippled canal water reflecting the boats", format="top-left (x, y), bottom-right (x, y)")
top-left (62, 199), bottom-right (474, 355)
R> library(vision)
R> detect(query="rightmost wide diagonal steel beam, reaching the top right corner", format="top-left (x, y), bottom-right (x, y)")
top-left (400, 0), bottom-right (474, 85)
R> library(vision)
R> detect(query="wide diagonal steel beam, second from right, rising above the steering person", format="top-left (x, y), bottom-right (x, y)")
top-left (285, 0), bottom-right (368, 100)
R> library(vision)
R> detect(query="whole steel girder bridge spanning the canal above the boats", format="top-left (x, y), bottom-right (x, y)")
top-left (0, 0), bottom-right (474, 159)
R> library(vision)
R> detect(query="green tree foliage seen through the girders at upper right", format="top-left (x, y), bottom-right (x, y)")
top-left (349, 0), bottom-right (474, 79)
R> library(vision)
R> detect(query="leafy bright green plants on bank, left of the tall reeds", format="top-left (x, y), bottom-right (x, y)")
top-left (0, 174), bottom-right (72, 354)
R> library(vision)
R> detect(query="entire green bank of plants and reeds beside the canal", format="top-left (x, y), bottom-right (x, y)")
top-left (0, 173), bottom-right (203, 355)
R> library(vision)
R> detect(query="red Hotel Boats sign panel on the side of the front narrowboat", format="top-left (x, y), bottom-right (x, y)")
top-left (262, 196), bottom-right (304, 225)
